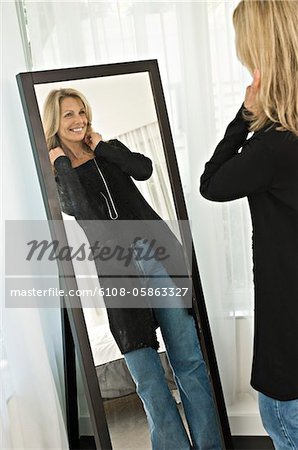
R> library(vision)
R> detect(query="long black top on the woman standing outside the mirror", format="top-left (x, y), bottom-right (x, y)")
top-left (200, 106), bottom-right (298, 400)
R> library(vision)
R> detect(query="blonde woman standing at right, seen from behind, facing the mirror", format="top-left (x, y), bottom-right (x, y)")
top-left (201, 0), bottom-right (298, 450)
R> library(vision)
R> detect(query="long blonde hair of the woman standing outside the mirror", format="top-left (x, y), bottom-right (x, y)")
top-left (233, 0), bottom-right (298, 135)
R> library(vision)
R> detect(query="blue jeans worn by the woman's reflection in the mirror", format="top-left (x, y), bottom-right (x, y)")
top-left (124, 239), bottom-right (222, 450)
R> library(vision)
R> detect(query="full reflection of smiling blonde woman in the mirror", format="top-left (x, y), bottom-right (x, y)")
top-left (43, 89), bottom-right (222, 450)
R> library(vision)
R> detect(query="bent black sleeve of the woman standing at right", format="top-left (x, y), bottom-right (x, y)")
top-left (200, 105), bottom-right (275, 201)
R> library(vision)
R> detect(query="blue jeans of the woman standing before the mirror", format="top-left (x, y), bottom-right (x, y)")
top-left (259, 393), bottom-right (298, 450)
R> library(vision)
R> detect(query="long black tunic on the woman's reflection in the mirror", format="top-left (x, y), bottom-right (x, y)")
top-left (54, 140), bottom-right (189, 353)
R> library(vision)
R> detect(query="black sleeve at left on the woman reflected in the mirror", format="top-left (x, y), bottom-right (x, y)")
top-left (54, 156), bottom-right (96, 220)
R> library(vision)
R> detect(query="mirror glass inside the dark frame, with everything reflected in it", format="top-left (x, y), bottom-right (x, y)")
top-left (35, 72), bottom-right (222, 450)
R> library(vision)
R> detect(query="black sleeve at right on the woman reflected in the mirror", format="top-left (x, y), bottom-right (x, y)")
top-left (95, 139), bottom-right (152, 181)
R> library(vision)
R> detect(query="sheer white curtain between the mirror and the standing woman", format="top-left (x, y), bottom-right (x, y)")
top-left (21, 0), bottom-right (260, 434)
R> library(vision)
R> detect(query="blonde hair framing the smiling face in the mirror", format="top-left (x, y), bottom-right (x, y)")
top-left (43, 88), bottom-right (92, 150)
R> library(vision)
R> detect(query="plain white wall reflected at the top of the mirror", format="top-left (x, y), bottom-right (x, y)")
top-left (35, 72), bottom-right (157, 139)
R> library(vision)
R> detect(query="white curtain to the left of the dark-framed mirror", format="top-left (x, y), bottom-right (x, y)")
top-left (0, 2), bottom-right (68, 450)
